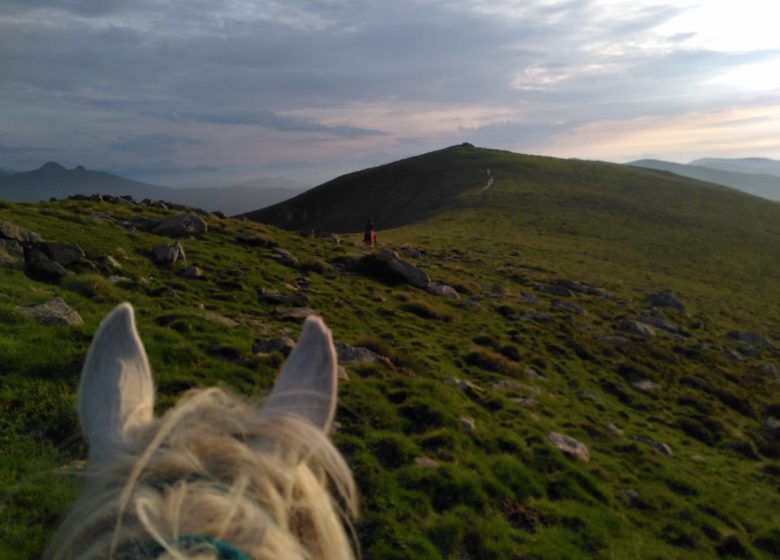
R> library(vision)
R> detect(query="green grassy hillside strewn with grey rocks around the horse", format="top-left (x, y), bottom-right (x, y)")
top-left (0, 147), bottom-right (780, 559)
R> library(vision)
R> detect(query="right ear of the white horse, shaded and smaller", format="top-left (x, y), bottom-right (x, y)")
top-left (260, 317), bottom-right (337, 432)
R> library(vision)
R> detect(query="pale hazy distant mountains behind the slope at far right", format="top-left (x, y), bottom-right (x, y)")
top-left (629, 158), bottom-right (780, 201)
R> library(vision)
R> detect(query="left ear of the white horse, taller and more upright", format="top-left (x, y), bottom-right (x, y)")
top-left (78, 303), bottom-right (154, 460)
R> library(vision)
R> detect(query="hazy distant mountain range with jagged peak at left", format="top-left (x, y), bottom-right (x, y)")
top-left (0, 162), bottom-right (305, 215)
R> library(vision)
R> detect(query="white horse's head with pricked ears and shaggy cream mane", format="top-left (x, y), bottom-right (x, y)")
top-left (44, 303), bottom-right (357, 560)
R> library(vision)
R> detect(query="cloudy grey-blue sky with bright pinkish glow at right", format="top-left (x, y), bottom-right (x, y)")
top-left (0, 0), bottom-right (780, 186)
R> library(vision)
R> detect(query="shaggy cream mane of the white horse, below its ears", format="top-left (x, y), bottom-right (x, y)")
top-left (45, 306), bottom-right (357, 560)
